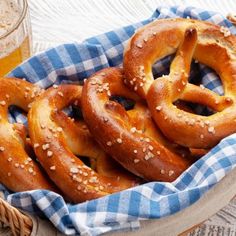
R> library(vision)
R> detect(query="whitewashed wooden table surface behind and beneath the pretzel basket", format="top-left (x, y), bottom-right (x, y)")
top-left (26, 0), bottom-right (236, 236)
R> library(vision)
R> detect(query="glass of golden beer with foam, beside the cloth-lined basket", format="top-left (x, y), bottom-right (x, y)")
top-left (0, 0), bottom-right (32, 77)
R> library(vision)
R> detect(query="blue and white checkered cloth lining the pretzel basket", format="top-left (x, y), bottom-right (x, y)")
top-left (1, 7), bottom-right (236, 235)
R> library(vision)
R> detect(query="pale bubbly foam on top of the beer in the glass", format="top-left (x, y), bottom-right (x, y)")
top-left (0, 0), bottom-right (20, 37)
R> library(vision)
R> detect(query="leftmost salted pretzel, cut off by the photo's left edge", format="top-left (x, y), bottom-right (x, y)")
top-left (0, 78), bottom-right (57, 192)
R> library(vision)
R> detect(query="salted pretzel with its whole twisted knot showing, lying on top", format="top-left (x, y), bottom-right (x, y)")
top-left (124, 18), bottom-right (236, 149)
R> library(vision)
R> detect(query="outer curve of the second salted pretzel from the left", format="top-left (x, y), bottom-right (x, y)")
top-left (28, 85), bottom-right (138, 202)
